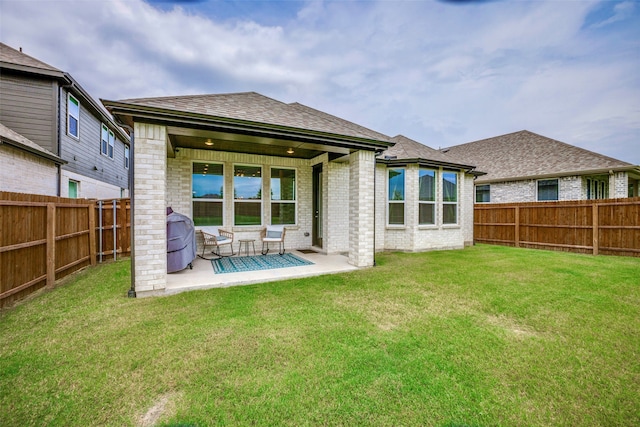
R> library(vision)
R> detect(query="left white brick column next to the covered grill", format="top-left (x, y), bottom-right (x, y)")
top-left (133, 123), bottom-right (167, 296)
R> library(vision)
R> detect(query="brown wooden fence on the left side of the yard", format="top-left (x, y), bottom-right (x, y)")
top-left (0, 192), bottom-right (131, 307)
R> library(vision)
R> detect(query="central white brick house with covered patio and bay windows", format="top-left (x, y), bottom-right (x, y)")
top-left (102, 92), bottom-right (473, 295)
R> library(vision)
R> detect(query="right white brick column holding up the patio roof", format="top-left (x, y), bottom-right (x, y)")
top-left (349, 151), bottom-right (375, 267)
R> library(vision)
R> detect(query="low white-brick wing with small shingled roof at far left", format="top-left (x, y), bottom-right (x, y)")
top-left (0, 123), bottom-right (66, 196)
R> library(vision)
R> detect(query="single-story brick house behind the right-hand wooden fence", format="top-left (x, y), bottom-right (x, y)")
top-left (442, 130), bottom-right (640, 203)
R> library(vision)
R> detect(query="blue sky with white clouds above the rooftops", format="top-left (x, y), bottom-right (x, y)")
top-left (0, 0), bottom-right (640, 165)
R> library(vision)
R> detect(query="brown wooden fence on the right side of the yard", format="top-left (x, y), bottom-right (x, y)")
top-left (474, 197), bottom-right (640, 256)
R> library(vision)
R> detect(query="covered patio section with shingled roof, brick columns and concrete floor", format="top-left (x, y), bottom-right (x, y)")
top-left (102, 92), bottom-right (394, 296)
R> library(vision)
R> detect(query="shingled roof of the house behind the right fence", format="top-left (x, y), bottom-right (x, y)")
top-left (442, 130), bottom-right (634, 183)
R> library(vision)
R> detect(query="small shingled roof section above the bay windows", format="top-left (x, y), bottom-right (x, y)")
top-left (378, 135), bottom-right (474, 169)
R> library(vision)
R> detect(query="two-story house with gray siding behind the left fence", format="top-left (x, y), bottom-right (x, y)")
top-left (0, 43), bottom-right (129, 198)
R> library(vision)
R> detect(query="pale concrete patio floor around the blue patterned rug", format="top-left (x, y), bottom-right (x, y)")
top-left (165, 250), bottom-right (358, 294)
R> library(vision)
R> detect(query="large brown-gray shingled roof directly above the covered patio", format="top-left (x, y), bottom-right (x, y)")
top-left (115, 92), bottom-right (390, 142)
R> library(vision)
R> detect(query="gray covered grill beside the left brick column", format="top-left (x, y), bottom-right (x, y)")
top-left (167, 211), bottom-right (196, 273)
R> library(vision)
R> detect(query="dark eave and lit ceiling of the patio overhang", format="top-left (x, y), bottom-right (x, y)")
top-left (102, 100), bottom-right (394, 159)
